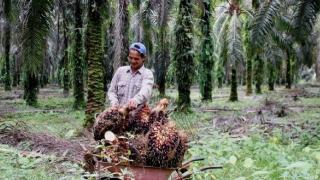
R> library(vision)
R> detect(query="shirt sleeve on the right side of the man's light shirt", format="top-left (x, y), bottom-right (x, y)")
top-left (132, 71), bottom-right (154, 104)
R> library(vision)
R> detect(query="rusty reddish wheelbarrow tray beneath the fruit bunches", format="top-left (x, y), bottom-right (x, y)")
top-left (96, 161), bottom-right (176, 180)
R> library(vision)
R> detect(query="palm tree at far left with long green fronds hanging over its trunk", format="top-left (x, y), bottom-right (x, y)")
top-left (22, 0), bottom-right (53, 106)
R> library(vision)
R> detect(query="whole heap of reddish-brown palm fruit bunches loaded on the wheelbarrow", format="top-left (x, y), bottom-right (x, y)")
top-left (94, 99), bottom-right (188, 168)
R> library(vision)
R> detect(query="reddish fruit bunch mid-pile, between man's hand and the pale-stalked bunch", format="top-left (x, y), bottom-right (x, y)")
top-left (129, 104), bottom-right (152, 134)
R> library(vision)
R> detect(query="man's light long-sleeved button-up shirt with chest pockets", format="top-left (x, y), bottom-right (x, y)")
top-left (108, 66), bottom-right (154, 106)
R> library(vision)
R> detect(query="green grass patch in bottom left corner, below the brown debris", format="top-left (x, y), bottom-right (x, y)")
top-left (0, 144), bottom-right (83, 180)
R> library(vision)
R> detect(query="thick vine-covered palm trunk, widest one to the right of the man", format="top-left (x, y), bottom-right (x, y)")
top-left (174, 0), bottom-right (194, 111)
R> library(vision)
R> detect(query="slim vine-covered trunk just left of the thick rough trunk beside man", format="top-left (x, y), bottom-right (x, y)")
top-left (73, 0), bottom-right (85, 109)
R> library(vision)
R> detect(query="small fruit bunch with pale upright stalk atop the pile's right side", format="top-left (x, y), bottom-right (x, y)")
top-left (149, 98), bottom-right (169, 124)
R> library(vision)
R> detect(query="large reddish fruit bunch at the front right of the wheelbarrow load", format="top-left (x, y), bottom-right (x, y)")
top-left (146, 122), bottom-right (180, 167)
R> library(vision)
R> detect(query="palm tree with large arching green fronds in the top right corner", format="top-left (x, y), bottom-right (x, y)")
top-left (252, 0), bottom-right (320, 88)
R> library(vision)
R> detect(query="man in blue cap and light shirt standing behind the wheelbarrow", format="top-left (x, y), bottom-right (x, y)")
top-left (108, 43), bottom-right (154, 109)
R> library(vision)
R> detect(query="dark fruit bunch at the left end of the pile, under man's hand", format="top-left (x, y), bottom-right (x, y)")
top-left (93, 107), bottom-right (129, 141)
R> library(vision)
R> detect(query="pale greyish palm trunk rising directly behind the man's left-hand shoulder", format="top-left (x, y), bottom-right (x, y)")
top-left (113, 0), bottom-right (129, 71)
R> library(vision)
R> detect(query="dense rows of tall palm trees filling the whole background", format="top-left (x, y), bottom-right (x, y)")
top-left (0, 0), bottom-right (320, 127)
